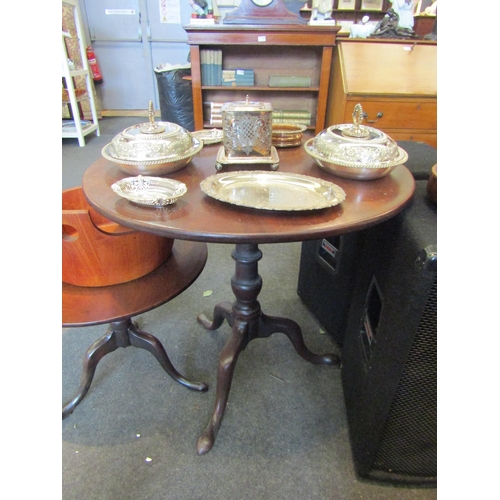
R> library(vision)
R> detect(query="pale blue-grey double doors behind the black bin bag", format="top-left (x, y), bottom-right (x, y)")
top-left (80, 0), bottom-right (191, 110)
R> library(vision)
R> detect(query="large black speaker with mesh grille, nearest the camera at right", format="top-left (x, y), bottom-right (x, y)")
top-left (341, 180), bottom-right (437, 487)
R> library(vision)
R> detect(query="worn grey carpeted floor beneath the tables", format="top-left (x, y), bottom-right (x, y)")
top-left (61, 117), bottom-right (437, 500)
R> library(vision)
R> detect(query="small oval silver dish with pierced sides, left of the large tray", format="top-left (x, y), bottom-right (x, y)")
top-left (111, 175), bottom-right (187, 207)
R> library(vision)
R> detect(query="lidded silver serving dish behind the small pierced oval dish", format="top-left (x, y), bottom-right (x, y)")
top-left (101, 102), bottom-right (203, 175)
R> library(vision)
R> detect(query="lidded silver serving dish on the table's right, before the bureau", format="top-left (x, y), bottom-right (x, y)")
top-left (304, 104), bottom-right (408, 180)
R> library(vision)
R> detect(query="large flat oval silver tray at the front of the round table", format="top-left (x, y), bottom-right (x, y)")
top-left (200, 171), bottom-right (346, 211)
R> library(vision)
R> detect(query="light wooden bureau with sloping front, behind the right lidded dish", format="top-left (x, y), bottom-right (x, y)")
top-left (326, 40), bottom-right (437, 147)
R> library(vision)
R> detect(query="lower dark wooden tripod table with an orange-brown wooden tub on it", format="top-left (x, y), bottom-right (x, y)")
top-left (62, 241), bottom-right (208, 419)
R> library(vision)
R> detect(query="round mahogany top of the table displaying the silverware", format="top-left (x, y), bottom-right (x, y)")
top-left (82, 136), bottom-right (415, 243)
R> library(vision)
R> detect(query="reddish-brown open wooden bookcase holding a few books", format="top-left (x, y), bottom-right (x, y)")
top-left (184, 25), bottom-right (340, 133)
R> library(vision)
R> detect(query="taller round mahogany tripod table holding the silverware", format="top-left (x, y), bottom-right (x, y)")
top-left (82, 137), bottom-right (415, 454)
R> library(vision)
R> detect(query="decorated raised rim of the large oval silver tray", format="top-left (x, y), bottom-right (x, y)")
top-left (200, 170), bottom-right (346, 212)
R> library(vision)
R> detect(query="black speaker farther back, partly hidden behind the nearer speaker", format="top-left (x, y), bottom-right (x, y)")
top-left (297, 231), bottom-right (362, 346)
